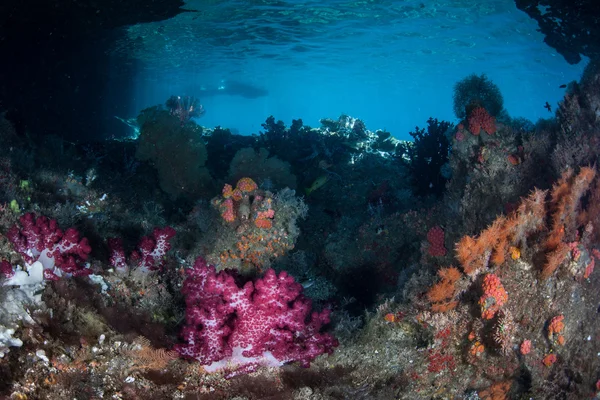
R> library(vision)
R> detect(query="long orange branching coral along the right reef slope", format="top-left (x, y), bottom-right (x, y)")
top-left (456, 167), bottom-right (600, 279)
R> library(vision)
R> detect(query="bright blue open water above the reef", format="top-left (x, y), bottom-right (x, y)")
top-left (119, 0), bottom-right (585, 139)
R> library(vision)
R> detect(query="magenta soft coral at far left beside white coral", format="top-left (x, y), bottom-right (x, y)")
top-left (6, 213), bottom-right (92, 280)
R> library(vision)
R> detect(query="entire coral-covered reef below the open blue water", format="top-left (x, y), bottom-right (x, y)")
top-left (0, 63), bottom-right (600, 400)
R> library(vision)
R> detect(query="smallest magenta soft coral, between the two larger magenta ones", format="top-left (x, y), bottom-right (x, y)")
top-left (107, 226), bottom-right (176, 271)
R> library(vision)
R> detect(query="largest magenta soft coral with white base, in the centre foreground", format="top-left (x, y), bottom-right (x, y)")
top-left (175, 258), bottom-right (338, 376)
